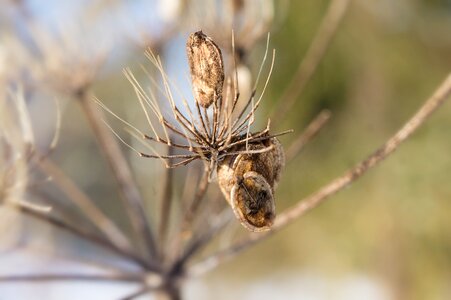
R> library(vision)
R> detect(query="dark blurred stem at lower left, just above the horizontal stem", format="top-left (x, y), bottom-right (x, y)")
top-left (20, 207), bottom-right (159, 272)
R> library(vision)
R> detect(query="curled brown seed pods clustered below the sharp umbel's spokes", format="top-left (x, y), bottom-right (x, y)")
top-left (218, 138), bottom-right (285, 231)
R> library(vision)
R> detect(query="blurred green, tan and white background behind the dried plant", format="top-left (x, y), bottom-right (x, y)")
top-left (0, 0), bottom-right (451, 299)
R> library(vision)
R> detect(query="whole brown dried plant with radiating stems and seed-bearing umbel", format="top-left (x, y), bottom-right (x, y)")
top-left (0, 0), bottom-right (451, 299)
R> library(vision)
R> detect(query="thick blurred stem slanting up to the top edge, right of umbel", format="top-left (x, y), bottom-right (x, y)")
top-left (271, 0), bottom-right (350, 120)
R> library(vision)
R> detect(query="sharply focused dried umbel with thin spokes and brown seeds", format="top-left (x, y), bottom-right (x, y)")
top-left (99, 31), bottom-right (290, 231)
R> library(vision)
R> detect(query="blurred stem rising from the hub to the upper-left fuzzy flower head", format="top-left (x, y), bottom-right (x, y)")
top-left (78, 91), bottom-right (156, 259)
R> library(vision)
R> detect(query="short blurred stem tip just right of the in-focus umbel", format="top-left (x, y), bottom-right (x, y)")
top-left (285, 110), bottom-right (331, 162)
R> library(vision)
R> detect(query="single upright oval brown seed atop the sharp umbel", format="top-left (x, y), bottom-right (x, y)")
top-left (186, 31), bottom-right (224, 108)
